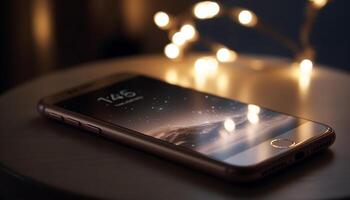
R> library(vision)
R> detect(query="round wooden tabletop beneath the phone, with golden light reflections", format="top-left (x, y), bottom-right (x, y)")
top-left (0, 55), bottom-right (350, 199)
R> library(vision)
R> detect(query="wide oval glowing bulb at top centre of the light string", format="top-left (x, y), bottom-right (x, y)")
top-left (193, 1), bottom-right (220, 19)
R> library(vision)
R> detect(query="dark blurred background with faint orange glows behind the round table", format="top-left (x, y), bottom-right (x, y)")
top-left (0, 0), bottom-right (350, 93)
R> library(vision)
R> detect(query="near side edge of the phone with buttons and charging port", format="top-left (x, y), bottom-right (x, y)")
top-left (37, 98), bottom-right (336, 182)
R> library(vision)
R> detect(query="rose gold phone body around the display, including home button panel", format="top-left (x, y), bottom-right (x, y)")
top-left (38, 74), bottom-right (335, 182)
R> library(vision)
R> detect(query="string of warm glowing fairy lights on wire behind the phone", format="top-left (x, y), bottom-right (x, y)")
top-left (153, 0), bottom-right (329, 81)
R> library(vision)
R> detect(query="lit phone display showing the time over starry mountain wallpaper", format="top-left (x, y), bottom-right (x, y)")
top-left (56, 76), bottom-right (305, 165)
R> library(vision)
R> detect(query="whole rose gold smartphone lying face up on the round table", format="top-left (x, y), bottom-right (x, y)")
top-left (38, 73), bottom-right (335, 182)
